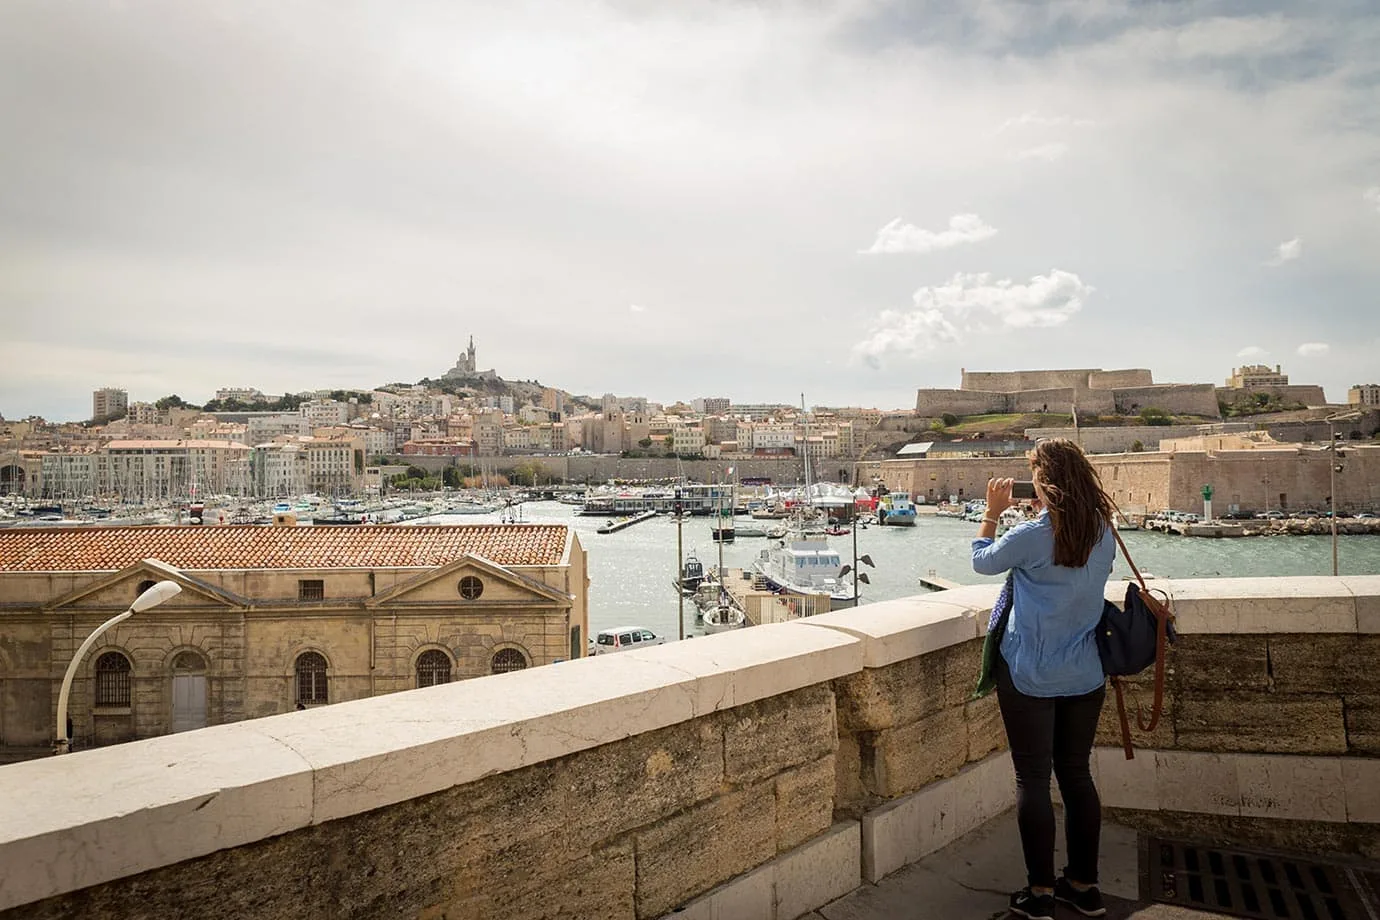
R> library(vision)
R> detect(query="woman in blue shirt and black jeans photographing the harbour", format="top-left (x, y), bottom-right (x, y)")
top-left (973, 439), bottom-right (1116, 920)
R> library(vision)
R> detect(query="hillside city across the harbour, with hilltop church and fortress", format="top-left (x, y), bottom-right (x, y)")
top-left (0, 339), bottom-right (1380, 501)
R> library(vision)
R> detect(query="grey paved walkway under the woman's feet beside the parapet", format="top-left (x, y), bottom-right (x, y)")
top-left (807, 810), bottom-right (1221, 920)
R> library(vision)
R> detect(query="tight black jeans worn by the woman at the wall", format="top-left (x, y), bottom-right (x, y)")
top-left (996, 655), bottom-right (1107, 888)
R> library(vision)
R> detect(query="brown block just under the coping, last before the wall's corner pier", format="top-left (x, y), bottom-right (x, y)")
top-left (723, 684), bottom-right (838, 783)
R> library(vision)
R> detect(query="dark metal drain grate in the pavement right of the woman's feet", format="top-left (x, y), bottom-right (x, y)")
top-left (1140, 836), bottom-right (1380, 920)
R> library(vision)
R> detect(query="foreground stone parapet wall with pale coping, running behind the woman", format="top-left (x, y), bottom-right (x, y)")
top-left (0, 577), bottom-right (1380, 920)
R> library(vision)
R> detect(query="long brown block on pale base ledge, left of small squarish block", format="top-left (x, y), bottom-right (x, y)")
top-left (635, 782), bottom-right (776, 917)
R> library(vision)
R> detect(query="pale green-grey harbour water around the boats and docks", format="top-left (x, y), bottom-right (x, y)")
top-left (417, 502), bottom-right (1380, 639)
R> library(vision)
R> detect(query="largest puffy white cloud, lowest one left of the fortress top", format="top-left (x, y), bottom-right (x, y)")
top-left (853, 269), bottom-right (1093, 368)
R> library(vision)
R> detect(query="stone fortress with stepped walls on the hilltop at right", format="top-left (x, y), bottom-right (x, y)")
top-left (915, 368), bottom-right (1221, 418)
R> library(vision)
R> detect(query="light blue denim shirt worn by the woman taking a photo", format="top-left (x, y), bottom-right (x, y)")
top-left (973, 512), bottom-right (1116, 697)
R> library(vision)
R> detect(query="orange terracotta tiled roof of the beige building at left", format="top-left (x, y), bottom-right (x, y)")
top-left (0, 524), bottom-right (567, 572)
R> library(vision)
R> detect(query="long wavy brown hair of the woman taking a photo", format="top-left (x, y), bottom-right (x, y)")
top-left (1031, 437), bottom-right (1114, 568)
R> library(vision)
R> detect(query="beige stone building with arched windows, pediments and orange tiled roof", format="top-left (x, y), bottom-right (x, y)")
top-left (0, 524), bottom-right (588, 757)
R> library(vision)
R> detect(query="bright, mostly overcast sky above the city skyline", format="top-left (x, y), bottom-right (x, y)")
top-left (0, 0), bottom-right (1380, 421)
